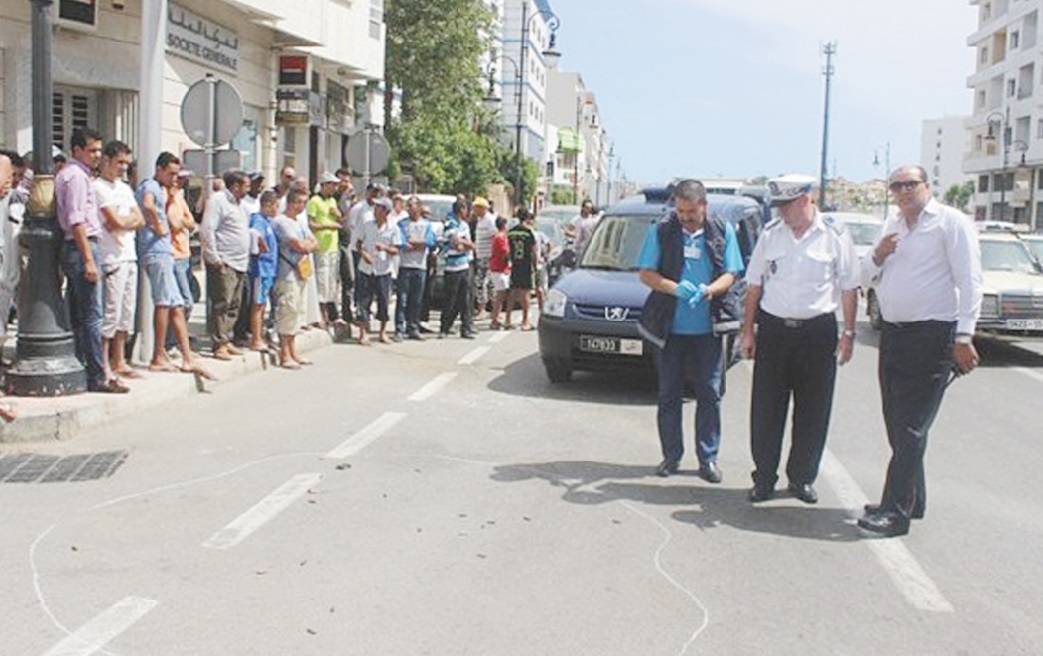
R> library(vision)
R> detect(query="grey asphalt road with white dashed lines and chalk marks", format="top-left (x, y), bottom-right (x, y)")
top-left (0, 314), bottom-right (1043, 656)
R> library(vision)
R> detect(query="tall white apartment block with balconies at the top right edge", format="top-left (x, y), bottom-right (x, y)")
top-left (959, 0), bottom-right (1043, 227)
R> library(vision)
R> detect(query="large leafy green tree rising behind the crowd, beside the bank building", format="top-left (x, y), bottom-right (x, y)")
top-left (384, 0), bottom-right (504, 193)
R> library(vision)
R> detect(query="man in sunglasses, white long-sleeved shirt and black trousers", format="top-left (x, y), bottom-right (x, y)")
top-left (858, 166), bottom-right (981, 537)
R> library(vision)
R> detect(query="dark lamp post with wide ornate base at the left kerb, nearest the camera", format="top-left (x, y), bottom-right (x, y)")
top-left (4, 0), bottom-right (87, 396)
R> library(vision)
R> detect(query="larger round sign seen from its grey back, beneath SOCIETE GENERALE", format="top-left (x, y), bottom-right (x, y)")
top-left (181, 73), bottom-right (243, 147)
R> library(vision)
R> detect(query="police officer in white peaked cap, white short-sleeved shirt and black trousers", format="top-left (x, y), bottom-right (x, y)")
top-left (739, 175), bottom-right (859, 504)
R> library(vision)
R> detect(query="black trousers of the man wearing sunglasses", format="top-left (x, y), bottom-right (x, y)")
top-left (878, 321), bottom-right (956, 519)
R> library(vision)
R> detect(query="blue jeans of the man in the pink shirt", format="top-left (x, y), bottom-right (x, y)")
top-left (62, 241), bottom-right (105, 386)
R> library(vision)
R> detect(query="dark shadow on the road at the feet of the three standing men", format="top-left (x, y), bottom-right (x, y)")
top-left (490, 454), bottom-right (860, 542)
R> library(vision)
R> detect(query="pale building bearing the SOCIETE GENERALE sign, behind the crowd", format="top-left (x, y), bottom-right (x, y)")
top-left (0, 0), bottom-right (385, 180)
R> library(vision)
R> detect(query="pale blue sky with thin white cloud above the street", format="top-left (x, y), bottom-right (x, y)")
top-left (551, 0), bottom-right (977, 183)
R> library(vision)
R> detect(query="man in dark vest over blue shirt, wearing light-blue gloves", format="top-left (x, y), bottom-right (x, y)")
top-left (637, 180), bottom-right (743, 483)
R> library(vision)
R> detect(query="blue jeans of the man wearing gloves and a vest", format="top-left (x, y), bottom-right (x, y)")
top-left (656, 334), bottom-right (724, 465)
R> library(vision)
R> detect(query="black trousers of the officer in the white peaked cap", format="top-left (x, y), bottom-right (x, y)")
top-left (750, 311), bottom-right (836, 488)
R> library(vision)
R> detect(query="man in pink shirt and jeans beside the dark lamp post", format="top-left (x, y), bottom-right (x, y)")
top-left (54, 128), bottom-right (128, 393)
